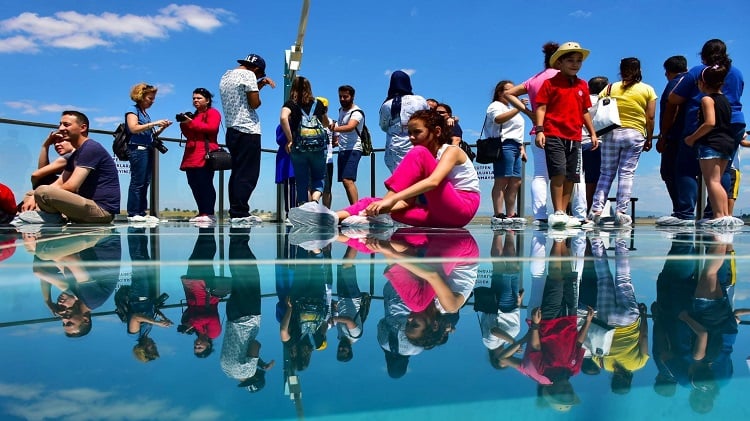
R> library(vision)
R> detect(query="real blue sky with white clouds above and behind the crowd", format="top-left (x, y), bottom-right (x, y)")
top-left (0, 0), bottom-right (750, 213)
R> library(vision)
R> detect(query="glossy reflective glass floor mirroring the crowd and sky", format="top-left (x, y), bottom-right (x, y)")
top-left (0, 222), bottom-right (750, 420)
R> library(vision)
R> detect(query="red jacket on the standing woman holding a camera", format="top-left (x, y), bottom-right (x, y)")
top-left (180, 108), bottom-right (221, 171)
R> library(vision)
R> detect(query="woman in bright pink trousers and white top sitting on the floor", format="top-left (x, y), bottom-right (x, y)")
top-left (289, 110), bottom-right (480, 228)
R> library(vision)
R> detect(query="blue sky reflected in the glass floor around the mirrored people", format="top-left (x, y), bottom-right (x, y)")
top-left (0, 225), bottom-right (750, 420)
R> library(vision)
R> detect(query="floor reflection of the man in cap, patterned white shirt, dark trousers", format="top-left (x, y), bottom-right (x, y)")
top-left (221, 227), bottom-right (274, 393)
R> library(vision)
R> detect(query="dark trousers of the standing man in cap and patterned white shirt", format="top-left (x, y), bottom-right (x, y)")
top-left (226, 127), bottom-right (260, 218)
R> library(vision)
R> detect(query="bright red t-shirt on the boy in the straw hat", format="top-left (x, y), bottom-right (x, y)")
top-left (536, 73), bottom-right (591, 142)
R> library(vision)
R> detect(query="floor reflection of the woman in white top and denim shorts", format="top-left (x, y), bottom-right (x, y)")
top-left (474, 231), bottom-right (524, 369)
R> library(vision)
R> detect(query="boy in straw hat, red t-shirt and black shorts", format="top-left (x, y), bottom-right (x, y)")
top-left (534, 42), bottom-right (599, 228)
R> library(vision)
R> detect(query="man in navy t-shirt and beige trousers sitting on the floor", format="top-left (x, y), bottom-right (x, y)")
top-left (18, 111), bottom-right (120, 224)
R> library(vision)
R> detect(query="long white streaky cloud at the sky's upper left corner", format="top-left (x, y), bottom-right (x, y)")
top-left (0, 4), bottom-right (232, 53)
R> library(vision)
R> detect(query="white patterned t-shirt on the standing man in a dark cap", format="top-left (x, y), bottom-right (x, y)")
top-left (219, 69), bottom-right (261, 134)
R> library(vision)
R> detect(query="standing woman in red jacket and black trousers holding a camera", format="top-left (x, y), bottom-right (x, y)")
top-left (177, 88), bottom-right (221, 223)
